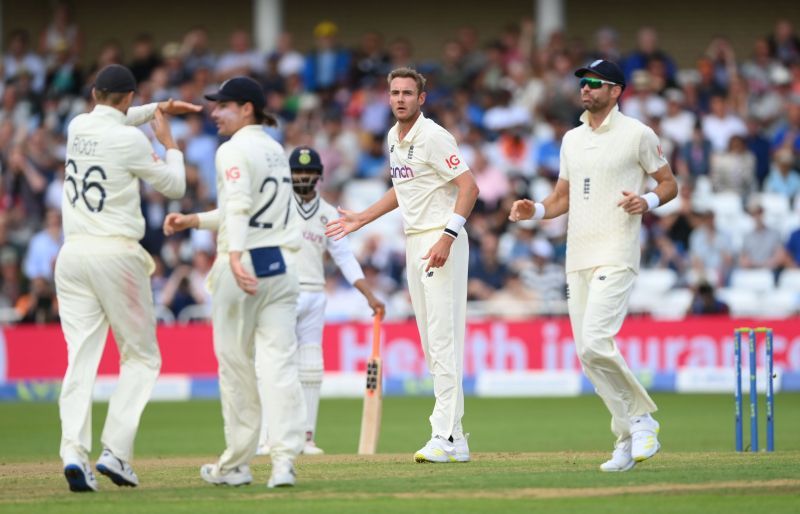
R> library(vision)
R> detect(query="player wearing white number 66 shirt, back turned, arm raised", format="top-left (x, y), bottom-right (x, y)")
top-left (55, 65), bottom-right (200, 492)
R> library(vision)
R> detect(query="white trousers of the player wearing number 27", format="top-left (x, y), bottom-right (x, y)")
top-left (209, 250), bottom-right (306, 473)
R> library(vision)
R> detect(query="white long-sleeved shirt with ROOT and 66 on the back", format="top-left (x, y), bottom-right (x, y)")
top-left (62, 104), bottom-right (186, 240)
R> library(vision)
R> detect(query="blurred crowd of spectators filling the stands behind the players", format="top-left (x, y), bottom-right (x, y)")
top-left (0, 5), bottom-right (800, 323)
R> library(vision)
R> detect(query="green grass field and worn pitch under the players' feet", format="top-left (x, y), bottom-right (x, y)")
top-left (0, 394), bottom-right (800, 508)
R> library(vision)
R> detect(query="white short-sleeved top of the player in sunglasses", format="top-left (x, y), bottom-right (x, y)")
top-left (559, 103), bottom-right (667, 273)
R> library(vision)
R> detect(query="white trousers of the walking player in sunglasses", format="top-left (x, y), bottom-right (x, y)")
top-left (567, 266), bottom-right (657, 441)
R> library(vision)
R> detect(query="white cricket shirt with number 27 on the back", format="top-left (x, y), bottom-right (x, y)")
top-left (198, 125), bottom-right (300, 253)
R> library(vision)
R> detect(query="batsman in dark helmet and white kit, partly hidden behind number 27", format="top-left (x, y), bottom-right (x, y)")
top-left (257, 147), bottom-right (385, 455)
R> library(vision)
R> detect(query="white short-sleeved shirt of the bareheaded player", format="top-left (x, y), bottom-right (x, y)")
top-left (388, 113), bottom-right (469, 234)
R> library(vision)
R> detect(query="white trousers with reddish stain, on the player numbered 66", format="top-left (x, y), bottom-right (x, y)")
top-left (55, 236), bottom-right (161, 462)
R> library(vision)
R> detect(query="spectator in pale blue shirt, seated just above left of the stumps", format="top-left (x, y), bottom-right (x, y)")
top-left (689, 207), bottom-right (735, 284)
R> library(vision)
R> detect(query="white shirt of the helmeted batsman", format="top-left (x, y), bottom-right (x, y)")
top-left (297, 195), bottom-right (364, 291)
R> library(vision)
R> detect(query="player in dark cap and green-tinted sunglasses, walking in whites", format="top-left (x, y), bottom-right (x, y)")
top-left (509, 60), bottom-right (678, 471)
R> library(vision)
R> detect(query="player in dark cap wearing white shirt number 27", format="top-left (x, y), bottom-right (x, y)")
top-left (164, 77), bottom-right (306, 487)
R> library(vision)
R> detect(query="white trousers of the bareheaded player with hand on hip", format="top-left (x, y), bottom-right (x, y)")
top-left (406, 229), bottom-right (469, 438)
